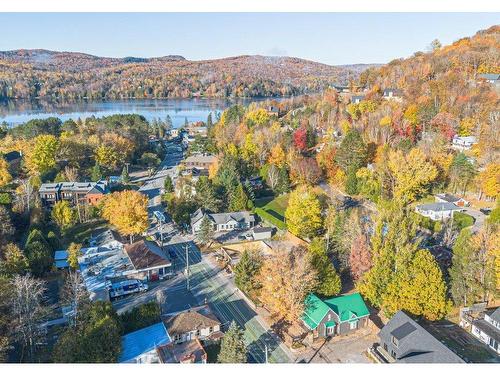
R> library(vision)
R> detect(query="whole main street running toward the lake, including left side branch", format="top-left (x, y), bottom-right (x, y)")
top-left (133, 142), bottom-right (293, 363)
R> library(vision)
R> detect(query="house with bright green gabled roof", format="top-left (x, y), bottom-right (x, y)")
top-left (301, 293), bottom-right (370, 339)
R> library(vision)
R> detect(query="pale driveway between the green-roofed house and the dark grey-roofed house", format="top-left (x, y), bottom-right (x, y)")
top-left (297, 326), bottom-right (378, 363)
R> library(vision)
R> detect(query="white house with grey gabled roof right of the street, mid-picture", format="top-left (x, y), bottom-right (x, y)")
top-left (191, 208), bottom-right (255, 234)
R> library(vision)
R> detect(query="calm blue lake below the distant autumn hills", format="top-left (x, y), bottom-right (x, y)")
top-left (0, 98), bottom-right (280, 127)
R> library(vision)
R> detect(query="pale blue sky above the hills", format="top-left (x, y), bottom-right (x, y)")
top-left (0, 13), bottom-right (500, 65)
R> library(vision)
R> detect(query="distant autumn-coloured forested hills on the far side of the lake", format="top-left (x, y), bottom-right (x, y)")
top-left (0, 50), bottom-right (369, 100)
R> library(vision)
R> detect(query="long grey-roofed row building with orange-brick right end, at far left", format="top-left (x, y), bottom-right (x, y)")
top-left (38, 180), bottom-right (109, 207)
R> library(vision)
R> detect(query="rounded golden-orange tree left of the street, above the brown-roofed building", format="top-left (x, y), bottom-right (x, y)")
top-left (102, 190), bottom-right (148, 242)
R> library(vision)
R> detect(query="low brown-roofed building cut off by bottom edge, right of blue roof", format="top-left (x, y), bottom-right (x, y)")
top-left (156, 339), bottom-right (208, 363)
